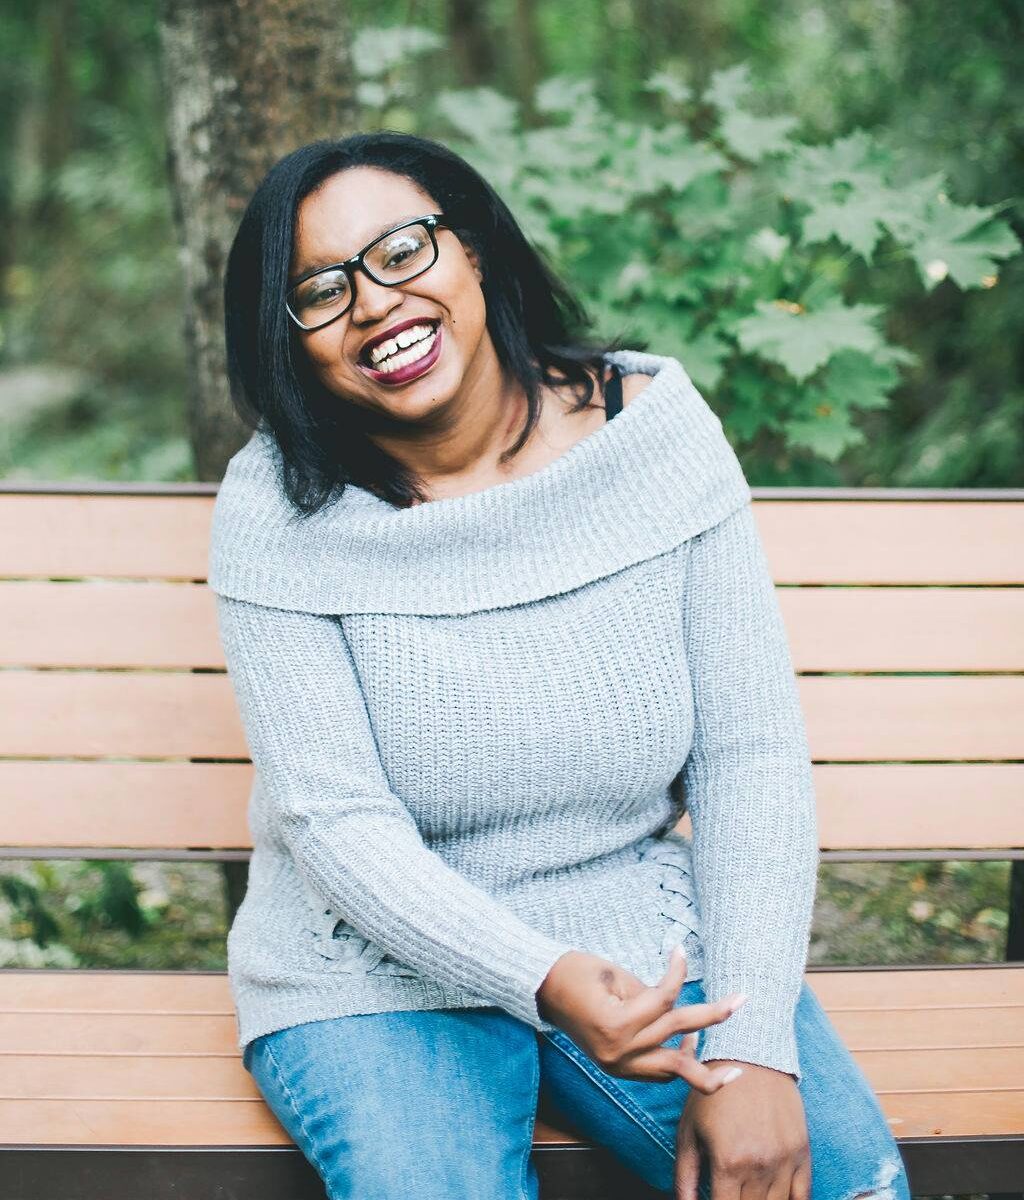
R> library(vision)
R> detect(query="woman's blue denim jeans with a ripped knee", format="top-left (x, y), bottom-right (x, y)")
top-left (244, 979), bottom-right (910, 1200)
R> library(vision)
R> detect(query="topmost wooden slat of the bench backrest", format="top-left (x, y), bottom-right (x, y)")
top-left (0, 493), bottom-right (1024, 584)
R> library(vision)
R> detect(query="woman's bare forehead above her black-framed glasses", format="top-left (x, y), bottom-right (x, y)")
top-left (292, 167), bottom-right (438, 275)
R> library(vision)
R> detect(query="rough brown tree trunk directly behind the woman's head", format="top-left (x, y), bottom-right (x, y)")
top-left (160, 0), bottom-right (355, 480)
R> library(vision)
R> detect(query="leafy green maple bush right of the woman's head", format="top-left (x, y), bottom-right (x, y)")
top-left (412, 58), bottom-right (1020, 463)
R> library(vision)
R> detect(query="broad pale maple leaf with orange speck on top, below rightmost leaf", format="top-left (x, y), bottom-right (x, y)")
top-left (736, 296), bottom-right (882, 383)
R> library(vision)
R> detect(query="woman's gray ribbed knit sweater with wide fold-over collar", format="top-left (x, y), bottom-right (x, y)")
top-left (209, 350), bottom-right (818, 1079)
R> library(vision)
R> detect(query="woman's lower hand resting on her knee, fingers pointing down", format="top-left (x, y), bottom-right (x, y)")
top-left (675, 1058), bottom-right (810, 1200)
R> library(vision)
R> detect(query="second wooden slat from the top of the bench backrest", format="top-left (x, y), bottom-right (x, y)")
top-left (0, 581), bottom-right (1024, 672)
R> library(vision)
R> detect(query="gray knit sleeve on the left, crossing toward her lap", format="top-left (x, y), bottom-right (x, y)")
top-left (217, 595), bottom-right (573, 1028)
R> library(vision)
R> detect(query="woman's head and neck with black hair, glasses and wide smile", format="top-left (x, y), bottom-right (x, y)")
top-left (224, 132), bottom-right (629, 514)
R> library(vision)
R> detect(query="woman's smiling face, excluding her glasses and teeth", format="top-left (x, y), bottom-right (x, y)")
top-left (291, 167), bottom-right (497, 421)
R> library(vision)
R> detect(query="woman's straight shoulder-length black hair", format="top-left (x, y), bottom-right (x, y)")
top-left (224, 130), bottom-right (646, 516)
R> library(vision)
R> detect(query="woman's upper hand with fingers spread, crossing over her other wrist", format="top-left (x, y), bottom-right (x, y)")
top-left (537, 947), bottom-right (745, 1096)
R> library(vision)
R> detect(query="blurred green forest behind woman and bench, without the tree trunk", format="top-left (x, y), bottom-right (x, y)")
top-left (0, 0), bottom-right (1024, 1041)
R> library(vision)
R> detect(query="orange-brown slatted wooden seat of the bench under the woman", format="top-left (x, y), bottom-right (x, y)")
top-left (0, 967), bottom-right (1024, 1146)
